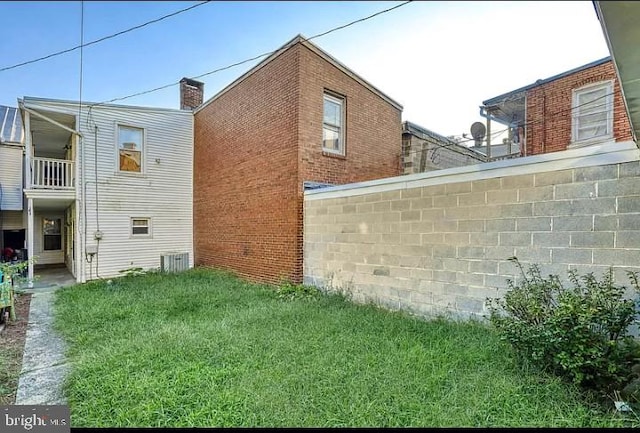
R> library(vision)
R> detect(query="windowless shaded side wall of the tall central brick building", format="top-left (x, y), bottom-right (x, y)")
top-left (194, 45), bottom-right (299, 281)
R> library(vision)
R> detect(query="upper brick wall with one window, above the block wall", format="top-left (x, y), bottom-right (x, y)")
top-left (297, 45), bottom-right (402, 184)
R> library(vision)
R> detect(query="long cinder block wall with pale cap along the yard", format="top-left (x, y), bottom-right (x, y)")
top-left (304, 143), bottom-right (640, 317)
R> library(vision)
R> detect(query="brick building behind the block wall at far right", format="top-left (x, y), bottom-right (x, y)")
top-left (480, 57), bottom-right (632, 156)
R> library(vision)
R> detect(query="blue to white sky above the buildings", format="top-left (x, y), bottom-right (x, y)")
top-left (0, 1), bottom-right (609, 136)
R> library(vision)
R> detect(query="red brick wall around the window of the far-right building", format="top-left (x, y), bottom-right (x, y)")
top-left (526, 61), bottom-right (631, 155)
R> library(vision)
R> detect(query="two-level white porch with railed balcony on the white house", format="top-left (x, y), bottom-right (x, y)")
top-left (20, 101), bottom-right (79, 288)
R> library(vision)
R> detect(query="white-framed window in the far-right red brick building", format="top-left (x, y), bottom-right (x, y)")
top-left (571, 81), bottom-right (613, 143)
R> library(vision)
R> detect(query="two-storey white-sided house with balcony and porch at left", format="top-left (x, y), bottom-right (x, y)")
top-left (0, 91), bottom-right (193, 282)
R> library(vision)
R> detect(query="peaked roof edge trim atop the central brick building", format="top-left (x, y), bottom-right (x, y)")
top-left (194, 34), bottom-right (402, 113)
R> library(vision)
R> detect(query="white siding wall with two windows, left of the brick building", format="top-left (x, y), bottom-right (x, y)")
top-left (23, 102), bottom-right (193, 279)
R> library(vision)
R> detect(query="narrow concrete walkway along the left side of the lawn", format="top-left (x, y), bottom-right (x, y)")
top-left (15, 275), bottom-right (75, 405)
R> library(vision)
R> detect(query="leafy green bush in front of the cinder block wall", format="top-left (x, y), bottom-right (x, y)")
top-left (488, 257), bottom-right (640, 392)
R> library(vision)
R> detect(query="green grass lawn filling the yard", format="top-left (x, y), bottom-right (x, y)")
top-left (56, 269), bottom-right (636, 427)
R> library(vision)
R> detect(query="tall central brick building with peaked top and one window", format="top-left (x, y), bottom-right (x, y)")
top-left (191, 36), bottom-right (402, 283)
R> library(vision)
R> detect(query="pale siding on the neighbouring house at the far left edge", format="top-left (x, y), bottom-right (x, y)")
top-left (0, 144), bottom-right (23, 211)
